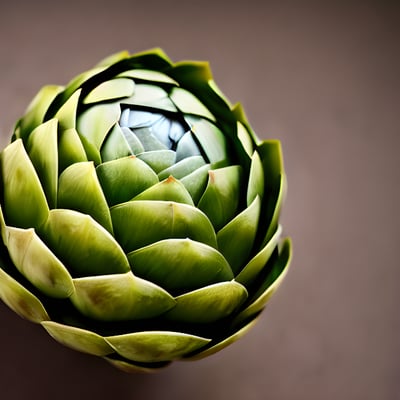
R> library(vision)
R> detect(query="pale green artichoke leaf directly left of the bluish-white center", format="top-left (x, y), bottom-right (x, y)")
top-left (77, 102), bottom-right (121, 150)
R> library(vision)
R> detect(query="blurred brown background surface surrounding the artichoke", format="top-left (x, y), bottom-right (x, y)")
top-left (0, 0), bottom-right (400, 400)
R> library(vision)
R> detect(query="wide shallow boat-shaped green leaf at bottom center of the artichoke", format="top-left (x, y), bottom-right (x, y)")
top-left (105, 331), bottom-right (210, 363)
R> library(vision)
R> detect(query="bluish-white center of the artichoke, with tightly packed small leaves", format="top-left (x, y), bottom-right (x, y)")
top-left (119, 107), bottom-right (208, 162)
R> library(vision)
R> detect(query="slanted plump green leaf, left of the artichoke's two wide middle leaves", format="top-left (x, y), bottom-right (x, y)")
top-left (38, 209), bottom-right (130, 276)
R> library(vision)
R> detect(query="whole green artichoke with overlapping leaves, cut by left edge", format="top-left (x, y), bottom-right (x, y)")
top-left (0, 49), bottom-right (291, 371)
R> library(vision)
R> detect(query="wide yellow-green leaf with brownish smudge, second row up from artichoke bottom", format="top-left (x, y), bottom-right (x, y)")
top-left (71, 271), bottom-right (175, 321)
